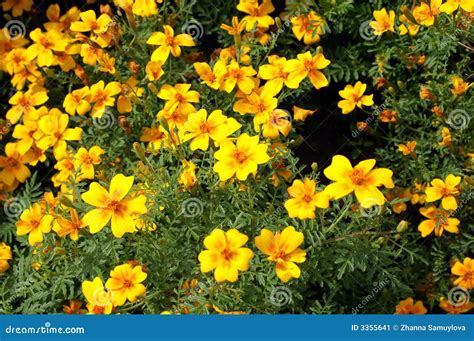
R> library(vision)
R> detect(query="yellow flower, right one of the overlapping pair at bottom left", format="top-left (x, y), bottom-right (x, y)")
top-left (105, 263), bottom-right (147, 306)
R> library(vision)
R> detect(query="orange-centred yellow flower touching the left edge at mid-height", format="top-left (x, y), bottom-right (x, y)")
top-left (0, 143), bottom-right (31, 186)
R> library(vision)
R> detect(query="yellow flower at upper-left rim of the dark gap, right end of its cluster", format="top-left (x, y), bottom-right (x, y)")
top-left (283, 51), bottom-right (331, 89)
